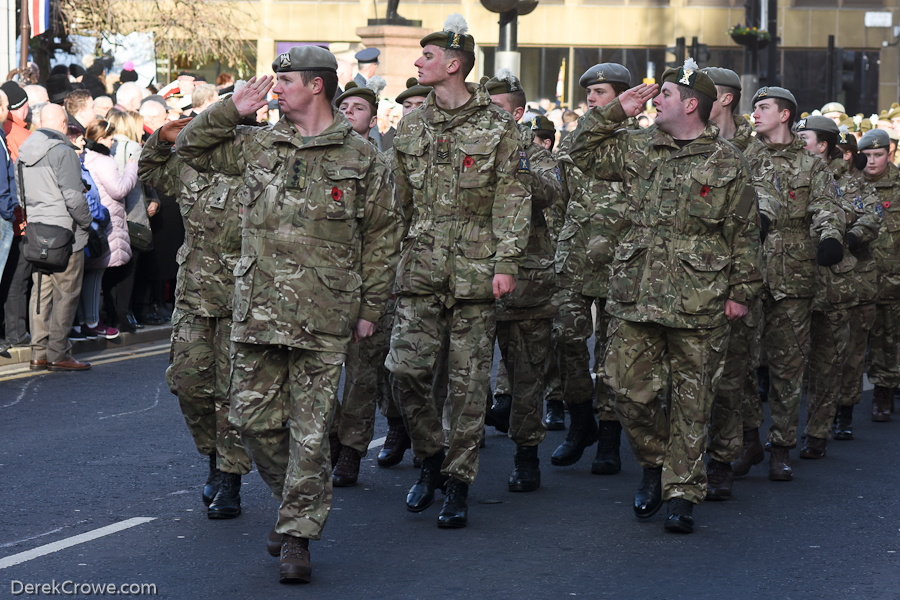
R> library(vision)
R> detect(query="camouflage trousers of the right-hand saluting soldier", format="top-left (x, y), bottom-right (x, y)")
top-left (605, 319), bottom-right (731, 504)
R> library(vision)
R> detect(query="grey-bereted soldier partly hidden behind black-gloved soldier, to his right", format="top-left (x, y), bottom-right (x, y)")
top-left (796, 115), bottom-right (881, 459)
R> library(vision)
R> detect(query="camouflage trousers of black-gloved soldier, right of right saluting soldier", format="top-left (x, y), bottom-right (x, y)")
top-left (760, 296), bottom-right (812, 448)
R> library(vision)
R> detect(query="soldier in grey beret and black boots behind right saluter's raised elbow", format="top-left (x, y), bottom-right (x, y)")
top-left (548, 63), bottom-right (638, 475)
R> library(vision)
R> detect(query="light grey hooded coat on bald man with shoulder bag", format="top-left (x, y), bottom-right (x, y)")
top-left (16, 128), bottom-right (92, 252)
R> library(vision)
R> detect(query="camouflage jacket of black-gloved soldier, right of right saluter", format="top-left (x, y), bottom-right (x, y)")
top-left (747, 133), bottom-right (844, 300)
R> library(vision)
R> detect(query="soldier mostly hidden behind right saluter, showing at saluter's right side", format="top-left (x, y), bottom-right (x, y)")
top-left (703, 67), bottom-right (780, 500)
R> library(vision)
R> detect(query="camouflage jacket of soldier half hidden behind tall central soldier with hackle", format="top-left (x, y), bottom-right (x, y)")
top-left (497, 125), bottom-right (565, 321)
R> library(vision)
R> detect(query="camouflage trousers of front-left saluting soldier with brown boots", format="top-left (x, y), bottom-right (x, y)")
top-left (229, 342), bottom-right (344, 540)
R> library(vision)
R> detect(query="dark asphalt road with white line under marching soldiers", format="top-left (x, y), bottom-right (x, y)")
top-left (0, 345), bottom-right (900, 600)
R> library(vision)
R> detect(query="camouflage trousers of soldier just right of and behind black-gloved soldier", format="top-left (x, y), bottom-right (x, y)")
top-left (805, 309), bottom-right (850, 439)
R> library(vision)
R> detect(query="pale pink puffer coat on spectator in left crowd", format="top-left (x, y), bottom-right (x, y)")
top-left (84, 146), bottom-right (137, 269)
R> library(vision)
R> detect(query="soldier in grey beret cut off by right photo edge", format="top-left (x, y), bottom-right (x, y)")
top-left (859, 129), bottom-right (900, 422)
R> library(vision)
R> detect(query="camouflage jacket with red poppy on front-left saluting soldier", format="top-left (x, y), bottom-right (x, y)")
top-left (176, 100), bottom-right (402, 352)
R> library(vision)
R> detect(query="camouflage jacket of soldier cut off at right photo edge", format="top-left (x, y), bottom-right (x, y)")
top-left (866, 164), bottom-right (900, 304)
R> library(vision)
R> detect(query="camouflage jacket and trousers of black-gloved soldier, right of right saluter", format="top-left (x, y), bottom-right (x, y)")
top-left (744, 134), bottom-right (844, 448)
